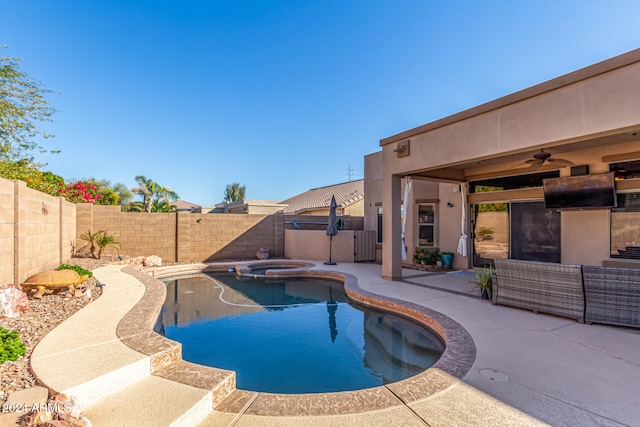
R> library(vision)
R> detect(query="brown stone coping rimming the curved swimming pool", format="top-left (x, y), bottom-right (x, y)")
top-left (116, 260), bottom-right (476, 416)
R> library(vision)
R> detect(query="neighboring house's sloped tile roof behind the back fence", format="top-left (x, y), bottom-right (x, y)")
top-left (280, 179), bottom-right (364, 214)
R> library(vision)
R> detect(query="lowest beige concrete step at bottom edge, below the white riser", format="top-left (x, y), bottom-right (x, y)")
top-left (82, 375), bottom-right (213, 427)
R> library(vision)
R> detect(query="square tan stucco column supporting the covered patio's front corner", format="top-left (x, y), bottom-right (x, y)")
top-left (382, 173), bottom-right (402, 280)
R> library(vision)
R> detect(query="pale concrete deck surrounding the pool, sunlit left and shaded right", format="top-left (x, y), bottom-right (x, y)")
top-left (20, 263), bottom-right (640, 427)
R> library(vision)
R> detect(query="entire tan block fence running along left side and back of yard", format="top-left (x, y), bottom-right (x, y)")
top-left (0, 178), bottom-right (363, 285)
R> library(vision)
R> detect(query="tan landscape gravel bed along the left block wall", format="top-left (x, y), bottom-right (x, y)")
top-left (0, 256), bottom-right (126, 404)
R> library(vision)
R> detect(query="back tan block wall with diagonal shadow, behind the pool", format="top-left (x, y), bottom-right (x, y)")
top-left (76, 204), bottom-right (284, 262)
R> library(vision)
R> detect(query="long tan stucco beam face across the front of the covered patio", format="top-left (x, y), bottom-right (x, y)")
top-left (381, 55), bottom-right (640, 175)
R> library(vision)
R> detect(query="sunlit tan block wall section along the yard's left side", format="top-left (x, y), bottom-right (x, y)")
top-left (0, 179), bottom-right (76, 284)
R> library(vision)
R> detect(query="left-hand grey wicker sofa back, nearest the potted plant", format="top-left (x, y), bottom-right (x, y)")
top-left (493, 258), bottom-right (585, 323)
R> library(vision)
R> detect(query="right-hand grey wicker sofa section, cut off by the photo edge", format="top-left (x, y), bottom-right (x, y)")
top-left (582, 265), bottom-right (640, 327)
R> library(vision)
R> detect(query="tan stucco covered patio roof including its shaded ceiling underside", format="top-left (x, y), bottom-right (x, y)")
top-left (380, 49), bottom-right (640, 181)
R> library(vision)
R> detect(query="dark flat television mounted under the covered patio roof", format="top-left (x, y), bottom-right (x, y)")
top-left (543, 173), bottom-right (616, 209)
